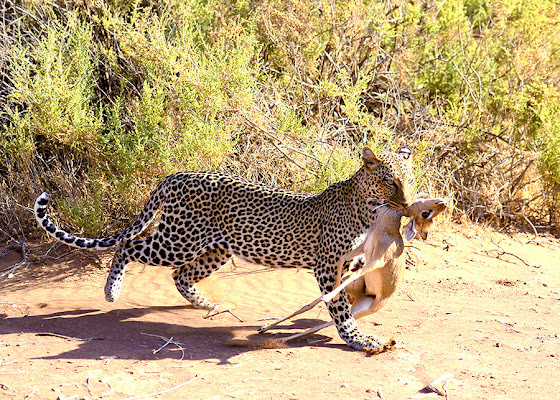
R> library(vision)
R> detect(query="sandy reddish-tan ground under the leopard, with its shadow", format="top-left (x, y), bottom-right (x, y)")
top-left (0, 226), bottom-right (560, 399)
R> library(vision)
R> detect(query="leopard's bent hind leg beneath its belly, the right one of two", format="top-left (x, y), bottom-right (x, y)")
top-left (173, 248), bottom-right (232, 310)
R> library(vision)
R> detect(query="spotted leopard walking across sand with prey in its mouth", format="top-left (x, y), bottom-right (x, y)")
top-left (34, 146), bottom-right (414, 350)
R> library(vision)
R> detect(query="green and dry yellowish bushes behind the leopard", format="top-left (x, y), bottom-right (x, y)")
top-left (0, 0), bottom-right (560, 236)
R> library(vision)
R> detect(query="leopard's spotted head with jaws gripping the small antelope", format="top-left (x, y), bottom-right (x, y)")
top-left (362, 147), bottom-right (414, 209)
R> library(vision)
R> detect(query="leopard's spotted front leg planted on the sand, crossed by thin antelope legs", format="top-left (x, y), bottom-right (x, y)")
top-left (314, 257), bottom-right (381, 350)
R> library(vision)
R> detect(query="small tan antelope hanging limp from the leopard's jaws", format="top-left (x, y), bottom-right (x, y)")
top-left (259, 198), bottom-right (447, 340)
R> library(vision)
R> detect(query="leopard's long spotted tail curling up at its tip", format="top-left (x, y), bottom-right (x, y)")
top-left (34, 179), bottom-right (168, 249)
